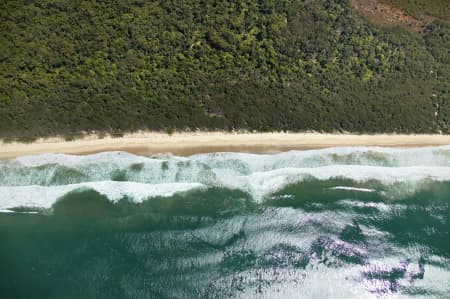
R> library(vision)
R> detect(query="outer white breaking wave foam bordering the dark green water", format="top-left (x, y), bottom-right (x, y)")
top-left (0, 165), bottom-right (450, 209)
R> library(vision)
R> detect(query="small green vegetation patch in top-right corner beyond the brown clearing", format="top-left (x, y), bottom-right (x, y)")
top-left (381, 0), bottom-right (450, 22)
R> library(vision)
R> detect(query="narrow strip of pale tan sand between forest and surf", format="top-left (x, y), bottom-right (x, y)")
top-left (0, 132), bottom-right (450, 159)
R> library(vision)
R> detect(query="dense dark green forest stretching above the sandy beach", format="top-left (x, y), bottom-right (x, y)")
top-left (0, 0), bottom-right (450, 140)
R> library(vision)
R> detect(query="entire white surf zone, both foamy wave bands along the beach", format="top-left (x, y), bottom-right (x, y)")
top-left (0, 146), bottom-right (450, 208)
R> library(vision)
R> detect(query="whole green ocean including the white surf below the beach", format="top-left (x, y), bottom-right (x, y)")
top-left (0, 146), bottom-right (450, 298)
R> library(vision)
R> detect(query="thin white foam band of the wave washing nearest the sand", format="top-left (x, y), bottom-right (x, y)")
top-left (8, 145), bottom-right (450, 171)
